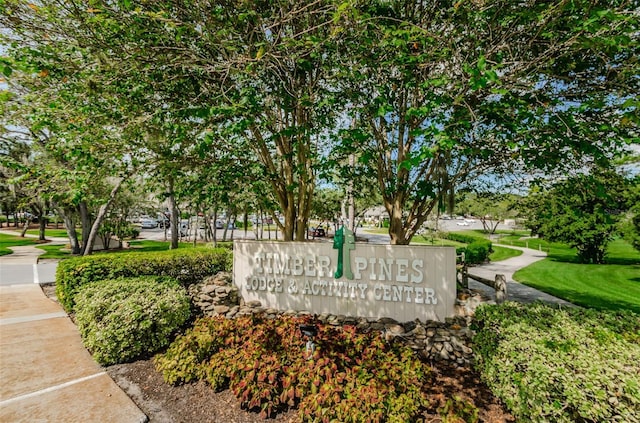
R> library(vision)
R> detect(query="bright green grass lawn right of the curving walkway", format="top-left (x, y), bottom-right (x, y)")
top-left (514, 240), bottom-right (640, 313)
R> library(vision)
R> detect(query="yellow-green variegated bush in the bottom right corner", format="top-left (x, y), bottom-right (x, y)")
top-left (474, 303), bottom-right (640, 422)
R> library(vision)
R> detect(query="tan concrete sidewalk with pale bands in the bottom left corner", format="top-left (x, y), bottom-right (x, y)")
top-left (0, 284), bottom-right (147, 423)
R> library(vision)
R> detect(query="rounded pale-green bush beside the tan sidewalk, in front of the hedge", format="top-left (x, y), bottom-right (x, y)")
top-left (75, 276), bottom-right (191, 365)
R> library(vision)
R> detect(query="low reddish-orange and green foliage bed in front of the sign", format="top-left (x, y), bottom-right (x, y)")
top-left (155, 316), bottom-right (426, 422)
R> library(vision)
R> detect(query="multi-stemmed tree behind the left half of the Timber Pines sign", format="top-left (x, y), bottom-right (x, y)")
top-left (3, 0), bottom-right (339, 240)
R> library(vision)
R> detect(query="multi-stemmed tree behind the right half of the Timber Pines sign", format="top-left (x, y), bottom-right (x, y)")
top-left (340, 0), bottom-right (640, 244)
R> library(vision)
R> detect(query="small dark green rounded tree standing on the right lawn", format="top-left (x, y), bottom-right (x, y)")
top-left (526, 168), bottom-right (629, 263)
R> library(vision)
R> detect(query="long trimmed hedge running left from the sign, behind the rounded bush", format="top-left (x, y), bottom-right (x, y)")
top-left (56, 248), bottom-right (232, 312)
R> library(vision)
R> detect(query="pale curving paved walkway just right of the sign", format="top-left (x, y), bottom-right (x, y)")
top-left (469, 244), bottom-right (574, 307)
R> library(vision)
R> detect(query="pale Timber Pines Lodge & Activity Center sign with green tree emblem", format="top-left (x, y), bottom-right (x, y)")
top-left (233, 238), bottom-right (456, 322)
